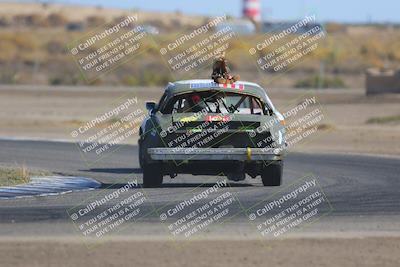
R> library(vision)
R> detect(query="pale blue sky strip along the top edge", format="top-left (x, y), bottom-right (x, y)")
top-left (12, 0), bottom-right (400, 23)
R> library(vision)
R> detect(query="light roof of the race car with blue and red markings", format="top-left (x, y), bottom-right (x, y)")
top-left (165, 79), bottom-right (266, 98)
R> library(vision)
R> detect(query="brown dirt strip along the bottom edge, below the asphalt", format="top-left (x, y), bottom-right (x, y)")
top-left (0, 237), bottom-right (400, 267)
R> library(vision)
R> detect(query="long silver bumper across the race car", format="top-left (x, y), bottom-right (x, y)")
top-left (147, 147), bottom-right (283, 161)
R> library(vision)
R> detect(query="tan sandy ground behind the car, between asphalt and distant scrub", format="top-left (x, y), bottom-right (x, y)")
top-left (0, 86), bottom-right (400, 155)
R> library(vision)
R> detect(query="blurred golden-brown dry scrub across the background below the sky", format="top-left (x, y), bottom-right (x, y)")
top-left (0, 9), bottom-right (400, 87)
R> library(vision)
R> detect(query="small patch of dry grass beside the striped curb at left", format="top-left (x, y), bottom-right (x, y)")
top-left (0, 166), bottom-right (50, 186)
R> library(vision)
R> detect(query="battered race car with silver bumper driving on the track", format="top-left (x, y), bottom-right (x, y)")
top-left (138, 80), bottom-right (286, 187)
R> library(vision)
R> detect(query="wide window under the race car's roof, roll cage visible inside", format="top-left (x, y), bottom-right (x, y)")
top-left (163, 91), bottom-right (264, 115)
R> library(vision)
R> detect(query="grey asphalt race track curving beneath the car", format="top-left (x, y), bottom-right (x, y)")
top-left (0, 140), bottom-right (400, 239)
